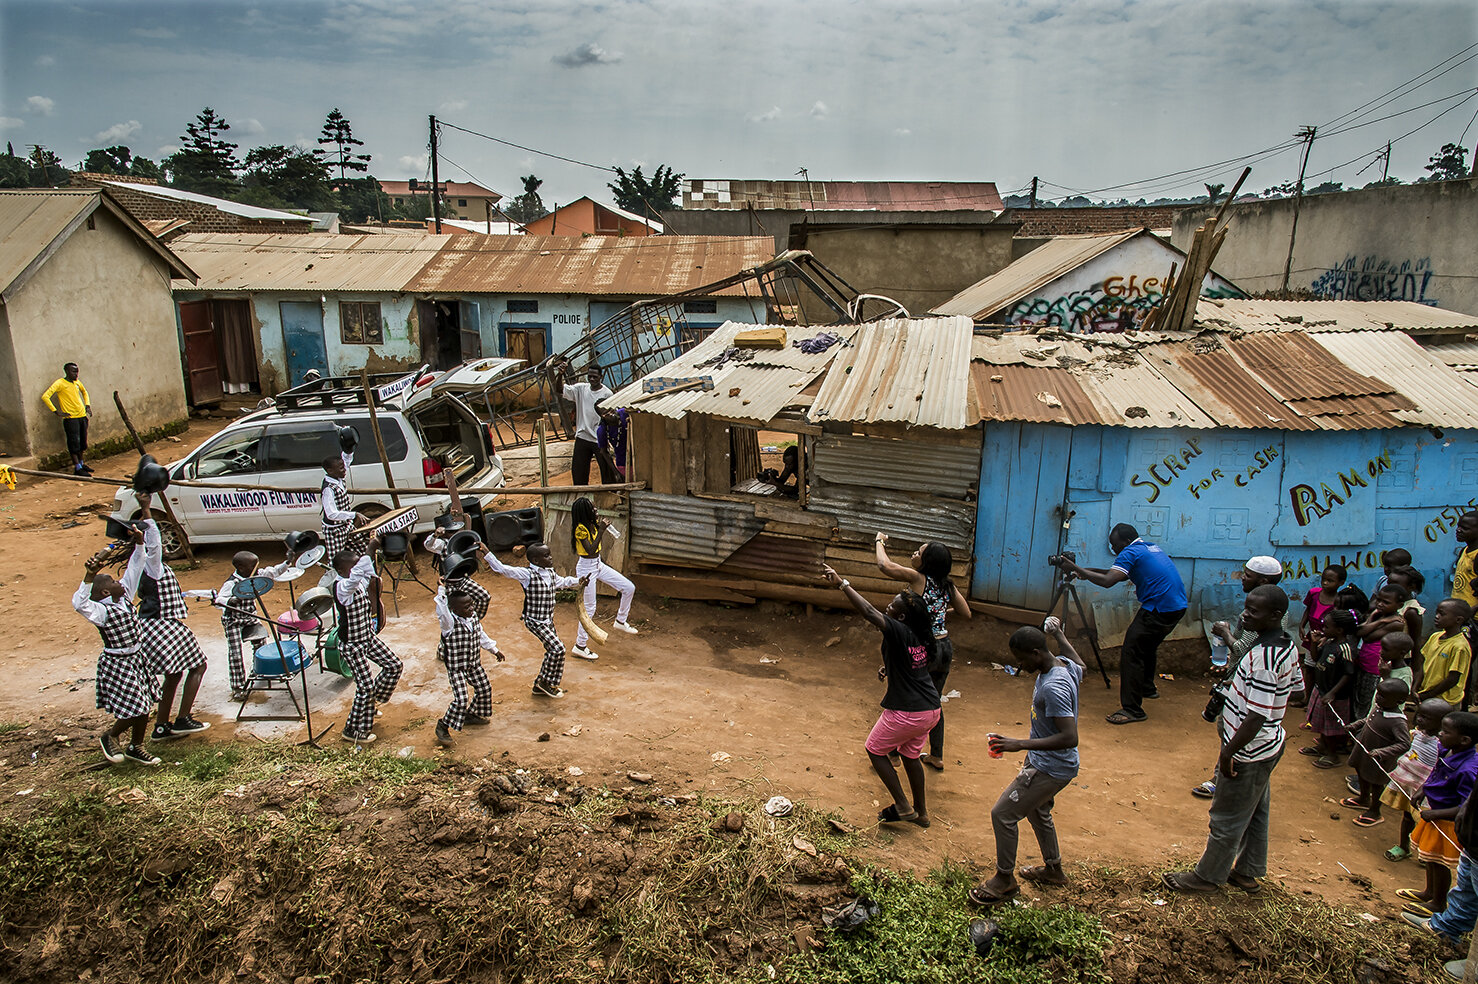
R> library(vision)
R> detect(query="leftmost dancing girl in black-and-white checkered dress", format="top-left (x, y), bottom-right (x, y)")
top-left (72, 543), bottom-right (160, 765)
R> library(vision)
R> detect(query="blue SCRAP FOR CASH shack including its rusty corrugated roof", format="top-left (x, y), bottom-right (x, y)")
top-left (971, 300), bottom-right (1478, 644)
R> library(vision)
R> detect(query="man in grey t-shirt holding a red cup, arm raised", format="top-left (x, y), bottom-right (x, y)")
top-left (970, 618), bottom-right (1083, 906)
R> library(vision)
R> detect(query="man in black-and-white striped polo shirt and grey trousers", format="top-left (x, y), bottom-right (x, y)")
top-left (1162, 585), bottom-right (1299, 894)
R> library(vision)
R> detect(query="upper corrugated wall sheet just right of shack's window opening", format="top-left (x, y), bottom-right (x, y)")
top-left (810, 431), bottom-right (980, 499)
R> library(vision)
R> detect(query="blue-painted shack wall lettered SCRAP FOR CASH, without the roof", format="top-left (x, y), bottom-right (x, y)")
top-left (971, 424), bottom-right (1478, 644)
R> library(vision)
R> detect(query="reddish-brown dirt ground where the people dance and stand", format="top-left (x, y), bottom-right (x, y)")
top-left (0, 421), bottom-right (1420, 919)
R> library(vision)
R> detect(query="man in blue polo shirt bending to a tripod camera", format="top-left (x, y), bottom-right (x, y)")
top-left (1058, 523), bottom-right (1185, 724)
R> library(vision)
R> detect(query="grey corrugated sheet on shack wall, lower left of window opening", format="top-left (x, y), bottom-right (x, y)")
top-left (631, 492), bottom-right (764, 567)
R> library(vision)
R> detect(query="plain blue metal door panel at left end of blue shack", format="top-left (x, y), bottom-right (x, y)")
top-left (970, 423), bottom-right (1073, 612)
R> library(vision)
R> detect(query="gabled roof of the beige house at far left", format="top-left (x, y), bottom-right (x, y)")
top-left (0, 188), bottom-right (195, 300)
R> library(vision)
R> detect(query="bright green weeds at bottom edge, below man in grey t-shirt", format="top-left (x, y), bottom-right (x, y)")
top-left (766, 864), bottom-right (1109, 984)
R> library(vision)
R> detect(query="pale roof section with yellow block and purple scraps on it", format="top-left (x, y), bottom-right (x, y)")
top-left (605, 321), bottom-right (857, 424)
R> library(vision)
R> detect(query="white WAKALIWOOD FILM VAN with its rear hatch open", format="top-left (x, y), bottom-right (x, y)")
top-left (112, 359), bottom-right (523, 558)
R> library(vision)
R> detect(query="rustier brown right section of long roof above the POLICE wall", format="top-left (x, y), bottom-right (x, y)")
top-left (405, 235), bottom-right (774, 297)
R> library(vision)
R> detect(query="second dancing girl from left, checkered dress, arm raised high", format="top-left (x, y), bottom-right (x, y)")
top-left (123, 495), bottom-right (210, 742)
